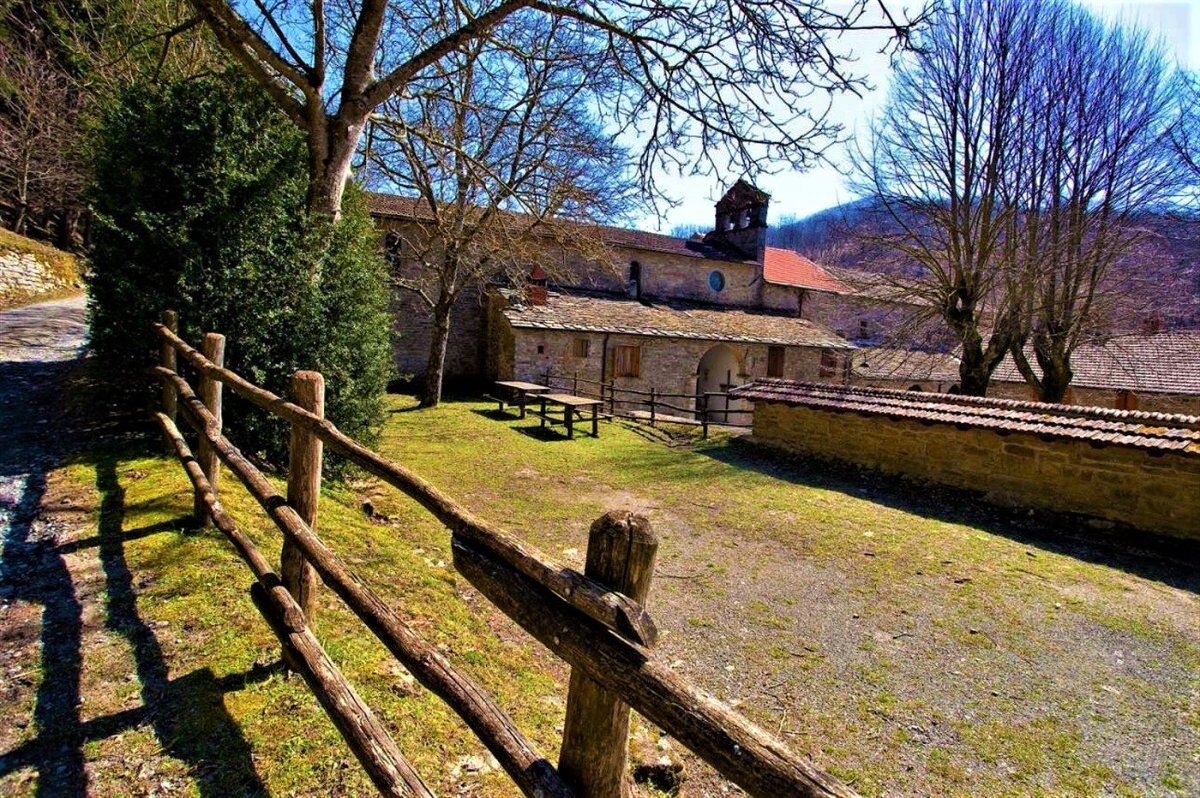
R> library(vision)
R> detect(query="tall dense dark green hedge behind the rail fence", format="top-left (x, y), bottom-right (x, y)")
top-left (88, 72), bottom-right (391, 462)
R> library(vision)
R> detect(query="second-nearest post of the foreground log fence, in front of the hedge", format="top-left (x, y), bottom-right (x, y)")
top-left (280, 371), bottom-right (325, 626)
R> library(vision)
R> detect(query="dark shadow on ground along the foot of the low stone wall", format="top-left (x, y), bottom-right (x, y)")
top-left (696, 438), bottom-right (1200, 593)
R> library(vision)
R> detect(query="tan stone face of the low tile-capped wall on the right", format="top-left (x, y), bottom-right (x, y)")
top-left (754, 388), bottom-right (1200, 540)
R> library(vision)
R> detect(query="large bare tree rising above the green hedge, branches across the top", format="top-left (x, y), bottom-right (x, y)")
top-left (190, 0), bottom-right (920, 217)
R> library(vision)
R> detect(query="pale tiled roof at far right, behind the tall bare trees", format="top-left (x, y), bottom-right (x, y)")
top-left (992, 330), bottom-right (1200, 396)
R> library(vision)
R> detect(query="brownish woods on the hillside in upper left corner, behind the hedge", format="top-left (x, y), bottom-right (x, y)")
top-left (0, 0), bottom-right (212, 248)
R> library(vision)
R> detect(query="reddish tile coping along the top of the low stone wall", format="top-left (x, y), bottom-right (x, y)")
top-left (730, 379), bottom-right (1200, 457)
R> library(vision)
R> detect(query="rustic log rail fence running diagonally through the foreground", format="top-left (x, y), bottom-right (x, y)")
top-left (154, 311), bottom-right (854, 798)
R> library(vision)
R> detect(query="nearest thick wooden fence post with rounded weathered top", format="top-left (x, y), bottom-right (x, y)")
top-left (558, 510), bottom-right (659, 798)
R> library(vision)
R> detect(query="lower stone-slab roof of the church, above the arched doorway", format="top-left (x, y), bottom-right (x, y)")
top-left (502, 290), bottom-right (853, 349)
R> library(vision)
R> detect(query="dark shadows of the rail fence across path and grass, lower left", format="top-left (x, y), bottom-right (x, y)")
top-left (0, 343), bottom-right (274, 798)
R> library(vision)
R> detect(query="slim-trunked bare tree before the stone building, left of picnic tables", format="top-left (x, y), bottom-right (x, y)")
top-left (367, 16), bottom-right (634, 407)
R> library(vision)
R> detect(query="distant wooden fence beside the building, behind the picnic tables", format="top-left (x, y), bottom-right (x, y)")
top-left (542, 371), bottom-right (754, 438)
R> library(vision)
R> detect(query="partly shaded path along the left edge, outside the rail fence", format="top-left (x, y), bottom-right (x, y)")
top-left (0, 296), bottom-right (86, 796)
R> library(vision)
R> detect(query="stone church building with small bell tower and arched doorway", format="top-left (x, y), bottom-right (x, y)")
top-left (371, 180), bottom-right (853, 409)
